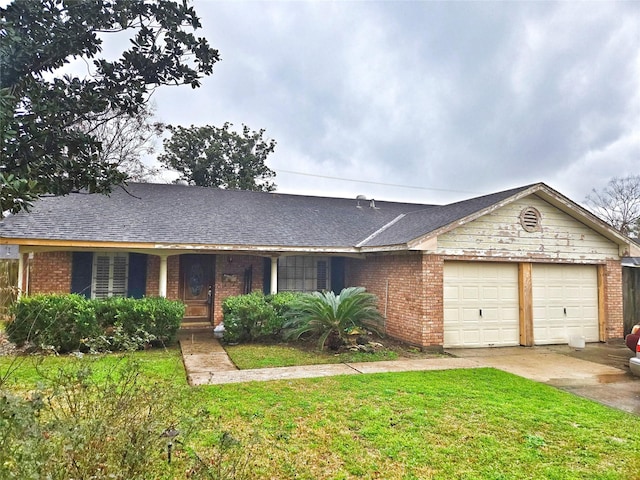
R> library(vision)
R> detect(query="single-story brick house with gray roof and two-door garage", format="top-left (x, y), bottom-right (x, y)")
top-left (0, 183), bottom-right (640, 347)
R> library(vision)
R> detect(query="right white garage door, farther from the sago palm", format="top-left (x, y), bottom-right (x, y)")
top-left (531, 264), bottom-right (600, 345)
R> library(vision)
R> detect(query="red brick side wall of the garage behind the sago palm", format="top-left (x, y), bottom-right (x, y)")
top-left (346, 253), bottom-right (427, 346)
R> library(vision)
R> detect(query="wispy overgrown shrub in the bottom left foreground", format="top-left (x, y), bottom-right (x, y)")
top-left (0, 358), bottom-right (175, 479)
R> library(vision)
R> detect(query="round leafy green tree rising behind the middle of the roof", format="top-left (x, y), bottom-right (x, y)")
top-left (158, 122), bottom-right (276, 192)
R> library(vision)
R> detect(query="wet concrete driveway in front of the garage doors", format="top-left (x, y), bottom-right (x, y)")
top-left (447, 343), bottom-right (640, 415)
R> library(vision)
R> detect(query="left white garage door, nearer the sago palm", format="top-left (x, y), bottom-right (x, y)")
top-left (444, 262), bottom-right (520, 348)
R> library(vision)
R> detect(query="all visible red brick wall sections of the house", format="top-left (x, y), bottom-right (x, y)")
top-left (25, 252), bottom-right (624, 347)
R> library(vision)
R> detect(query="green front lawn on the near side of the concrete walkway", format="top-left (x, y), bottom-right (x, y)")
top-left (0, 350), bottom-right (640, 480)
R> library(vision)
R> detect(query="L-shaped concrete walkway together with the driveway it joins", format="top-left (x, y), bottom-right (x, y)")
top-left (179, 329), bottom-right (640, 415)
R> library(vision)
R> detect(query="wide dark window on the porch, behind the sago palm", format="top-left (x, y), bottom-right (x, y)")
top-left (278, 256), bottom-right (330, 292)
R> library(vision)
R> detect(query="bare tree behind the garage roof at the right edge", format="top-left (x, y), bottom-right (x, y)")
top-left (585, 175), bottom-right (640, 236)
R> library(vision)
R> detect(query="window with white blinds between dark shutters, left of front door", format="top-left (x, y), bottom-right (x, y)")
top-left (91, 253), bottom-right (129, 298)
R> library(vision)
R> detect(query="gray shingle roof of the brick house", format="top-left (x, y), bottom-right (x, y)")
top-left (0, 183), bottom-right (530, 249)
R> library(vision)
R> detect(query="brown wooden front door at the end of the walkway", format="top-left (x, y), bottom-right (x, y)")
top-left (180, 255), bottom-right (215, 327)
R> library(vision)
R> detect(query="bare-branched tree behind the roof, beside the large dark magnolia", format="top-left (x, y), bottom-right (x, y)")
top-left (78, 105), bottom-right (164, 182)
